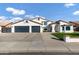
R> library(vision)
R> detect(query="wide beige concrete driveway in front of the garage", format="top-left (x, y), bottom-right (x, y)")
top-left (0, 33), bottom-right (79, 54)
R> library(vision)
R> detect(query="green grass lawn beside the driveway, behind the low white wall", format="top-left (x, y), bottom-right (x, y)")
top-left (52, 32), bottom-right (79, 40)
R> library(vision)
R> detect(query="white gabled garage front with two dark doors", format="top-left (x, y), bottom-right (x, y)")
top-left (11, 19), bottom-right (43, 33)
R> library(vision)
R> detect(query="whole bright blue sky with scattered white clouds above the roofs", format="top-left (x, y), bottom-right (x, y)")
top-left (0, 3), bottom-right (79, 21)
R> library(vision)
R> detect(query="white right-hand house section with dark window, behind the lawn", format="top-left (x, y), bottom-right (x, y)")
top-left (48, 20), bottom-right (74, 33)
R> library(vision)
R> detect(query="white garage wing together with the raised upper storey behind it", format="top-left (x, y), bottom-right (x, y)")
top-left (11, 17), bottom-right (51, 33)
